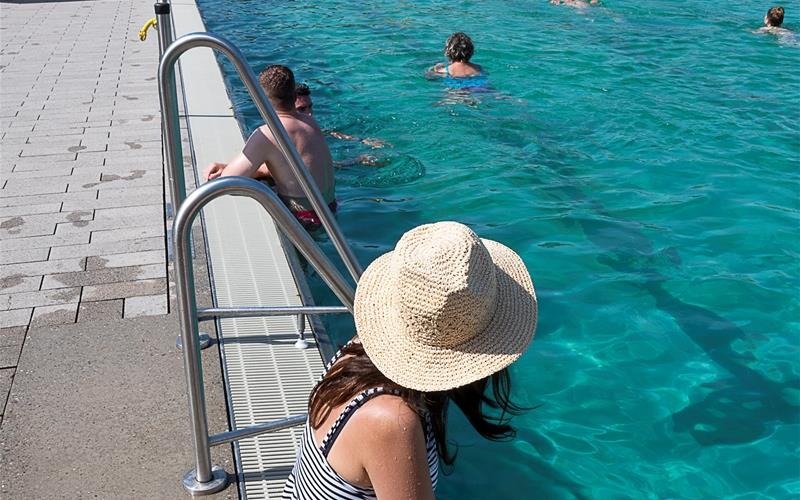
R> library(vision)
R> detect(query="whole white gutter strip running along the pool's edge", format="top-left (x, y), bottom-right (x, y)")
top-left (172, 0), bottom-right (333, 499)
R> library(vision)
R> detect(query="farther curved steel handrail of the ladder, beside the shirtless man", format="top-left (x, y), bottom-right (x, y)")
top-left (158, 33), bottom-right (363, 282)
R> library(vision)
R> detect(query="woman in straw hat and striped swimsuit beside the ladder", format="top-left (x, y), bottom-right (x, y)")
top-left (283, 222), bottom-right (537, 500)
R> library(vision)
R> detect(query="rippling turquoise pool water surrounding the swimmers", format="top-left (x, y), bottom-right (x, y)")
top-left (195, 0), bottom-right (800, 499)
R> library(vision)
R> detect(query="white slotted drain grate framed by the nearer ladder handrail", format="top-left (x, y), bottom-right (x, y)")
top-left (204, 196), bottom-right (323, 499)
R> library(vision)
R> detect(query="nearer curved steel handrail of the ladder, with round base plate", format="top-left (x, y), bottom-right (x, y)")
top-left (173, 177), bottom-right (355, 495)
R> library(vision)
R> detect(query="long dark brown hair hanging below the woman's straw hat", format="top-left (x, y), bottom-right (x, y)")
top-left (308, 342), bottom-right (526, 465)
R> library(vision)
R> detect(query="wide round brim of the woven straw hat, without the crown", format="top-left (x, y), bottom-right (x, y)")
top-left (354, 240), bottom-right (537, 392)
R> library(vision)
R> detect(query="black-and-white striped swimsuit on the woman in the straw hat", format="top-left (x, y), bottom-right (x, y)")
top-left (281, 351), bottom-right (439, 500)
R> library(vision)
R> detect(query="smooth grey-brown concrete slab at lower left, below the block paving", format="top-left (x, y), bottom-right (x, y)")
top-left (0, 315), bottom-right (238, 500)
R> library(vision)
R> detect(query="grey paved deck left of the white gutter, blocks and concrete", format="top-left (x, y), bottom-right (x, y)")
top-left (0, 0), bottom-right (238, 499)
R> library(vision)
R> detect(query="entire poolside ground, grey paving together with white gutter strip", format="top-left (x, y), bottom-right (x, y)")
top-left (0, 0), bottom-right (331, 498)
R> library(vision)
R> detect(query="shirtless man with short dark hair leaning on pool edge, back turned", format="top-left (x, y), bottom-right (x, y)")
top-left (203, 64), bottom-right (337, 231)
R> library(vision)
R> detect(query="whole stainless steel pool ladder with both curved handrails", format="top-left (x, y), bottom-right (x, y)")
top-left (156, 19), bottom-right (362, 496)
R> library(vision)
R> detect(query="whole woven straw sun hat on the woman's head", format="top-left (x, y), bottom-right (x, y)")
top-left (355, 222), bottom-right (536, 392)
